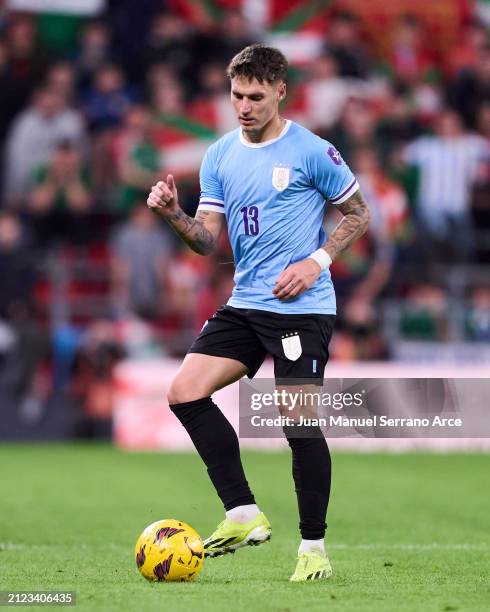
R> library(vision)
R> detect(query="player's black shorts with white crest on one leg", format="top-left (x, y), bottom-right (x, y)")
top-left (189, 306), bottom-right (335, 383)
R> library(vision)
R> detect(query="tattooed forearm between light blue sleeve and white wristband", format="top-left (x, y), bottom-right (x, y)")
top-left (323, 191), bottom-right (370, 261)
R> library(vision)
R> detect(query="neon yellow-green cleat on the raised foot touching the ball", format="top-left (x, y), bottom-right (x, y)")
top-left (204, 512), bottom-right (272, 557)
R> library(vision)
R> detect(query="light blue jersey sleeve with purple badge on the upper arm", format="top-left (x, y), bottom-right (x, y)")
top-left (310, 140), bottom-right (359, 204)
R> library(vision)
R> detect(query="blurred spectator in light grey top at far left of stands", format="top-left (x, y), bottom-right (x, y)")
top-left (5, 87), bottom-right (86, 204)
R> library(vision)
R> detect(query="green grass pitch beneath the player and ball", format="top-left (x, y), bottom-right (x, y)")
top-left (0, 445), bottom-right (490, 612)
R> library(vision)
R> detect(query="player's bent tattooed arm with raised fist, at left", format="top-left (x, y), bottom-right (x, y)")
top-left (147, 174), bottom-right (224, 255)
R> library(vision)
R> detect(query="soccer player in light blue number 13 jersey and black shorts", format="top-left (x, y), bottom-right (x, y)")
top-left (147, 45), bottom-right (369, 581)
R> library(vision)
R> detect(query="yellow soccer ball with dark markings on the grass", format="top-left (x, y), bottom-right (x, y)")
top-left (134, 519), bottom-right (204, 582)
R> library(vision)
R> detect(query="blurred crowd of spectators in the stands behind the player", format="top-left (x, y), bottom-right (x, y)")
top-left (0, 0), bottom-right (490, 440)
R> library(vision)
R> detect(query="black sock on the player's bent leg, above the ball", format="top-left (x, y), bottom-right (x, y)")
top-left (170, 397), bottom-right (255, 510)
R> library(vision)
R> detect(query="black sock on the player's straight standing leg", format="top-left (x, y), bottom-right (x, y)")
top-left (284, 427), bottom-right (332, 540)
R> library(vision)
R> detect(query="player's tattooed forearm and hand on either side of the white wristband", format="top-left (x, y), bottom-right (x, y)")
top-left (272, 191), bottom-right (369, 300)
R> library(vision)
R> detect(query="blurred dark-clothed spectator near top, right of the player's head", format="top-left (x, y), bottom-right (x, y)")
top-left (324, 12), bottom-right (369, 79)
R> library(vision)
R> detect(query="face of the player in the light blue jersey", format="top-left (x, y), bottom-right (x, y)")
top-left (231, 77), bottom-right (286, 135)
